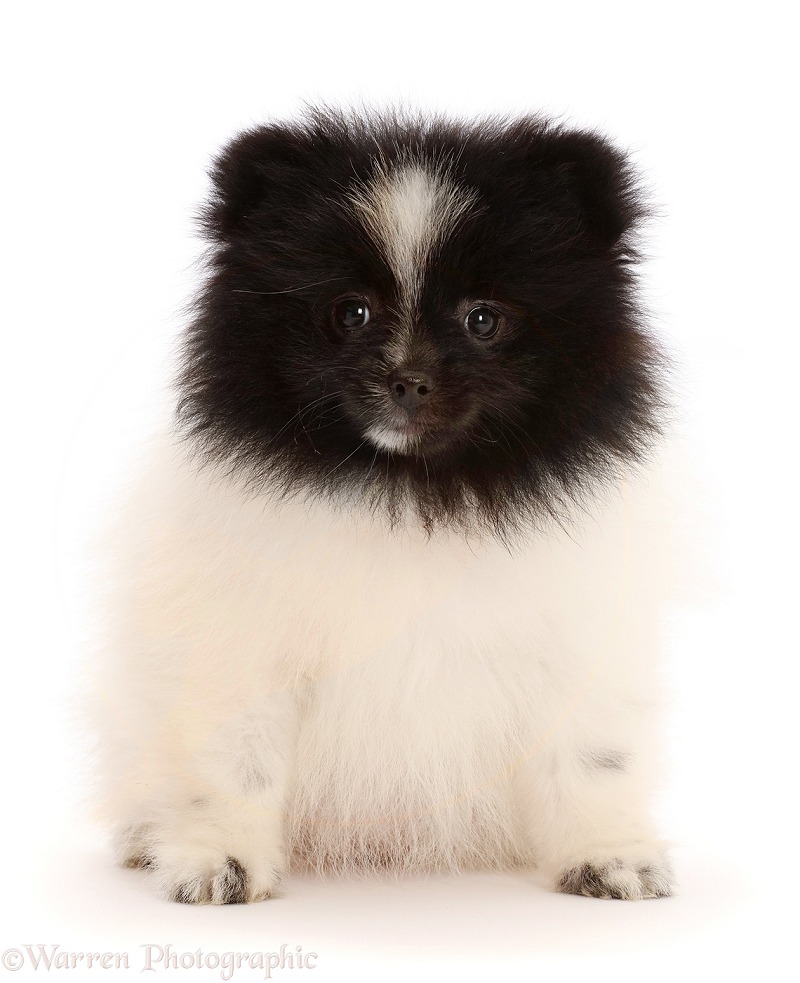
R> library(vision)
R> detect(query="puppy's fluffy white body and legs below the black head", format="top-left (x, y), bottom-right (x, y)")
top-left (94, 444), bottom-right (672, 901)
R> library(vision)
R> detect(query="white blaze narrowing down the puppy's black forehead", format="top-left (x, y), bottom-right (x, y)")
top-left (351, 159), bottom-right (477, 316)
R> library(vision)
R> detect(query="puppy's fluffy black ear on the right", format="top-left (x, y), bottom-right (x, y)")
top-left (541, 132), bottom-right (646, 248)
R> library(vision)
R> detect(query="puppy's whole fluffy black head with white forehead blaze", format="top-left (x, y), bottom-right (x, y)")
top-left (180, 110), bottom-right (660, 534)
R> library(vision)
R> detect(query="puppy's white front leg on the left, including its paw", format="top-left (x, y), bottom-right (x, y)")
top-left (129, 690), bottom-right (297, 904)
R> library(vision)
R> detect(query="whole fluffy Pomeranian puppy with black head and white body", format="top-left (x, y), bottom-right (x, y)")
top-left (95, 110), bottom-right (671, 904)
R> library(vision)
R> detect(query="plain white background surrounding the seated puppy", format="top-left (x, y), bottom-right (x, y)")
top-left (0, 0), bottom-right (800, 981)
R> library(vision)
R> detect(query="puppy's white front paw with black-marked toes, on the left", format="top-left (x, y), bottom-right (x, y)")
top-left (150, 845), bottom-right (282, 904)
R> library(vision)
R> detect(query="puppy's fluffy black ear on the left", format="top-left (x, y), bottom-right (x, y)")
top-left (203, 126), bottom-right (308, 242)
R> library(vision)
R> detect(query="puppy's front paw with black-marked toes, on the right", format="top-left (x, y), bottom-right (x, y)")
top-left (556, 858), bottom-right (672, 901)
